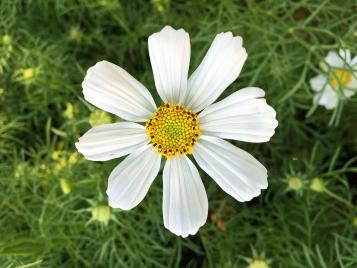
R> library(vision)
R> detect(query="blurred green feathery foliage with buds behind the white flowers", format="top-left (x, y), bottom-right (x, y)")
top-left (0, 0), bottom-right (357, 268)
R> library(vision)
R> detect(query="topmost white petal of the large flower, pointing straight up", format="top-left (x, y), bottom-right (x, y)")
top-left (149, 26), bottom-right (191, 103)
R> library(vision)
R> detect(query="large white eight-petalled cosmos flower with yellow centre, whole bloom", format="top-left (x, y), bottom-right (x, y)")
top-left (76, 26), bottom-right (278, 237)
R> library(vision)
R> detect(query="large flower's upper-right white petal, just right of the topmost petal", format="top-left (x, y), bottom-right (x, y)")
top-left (185, 32), bottom-right (247, 112)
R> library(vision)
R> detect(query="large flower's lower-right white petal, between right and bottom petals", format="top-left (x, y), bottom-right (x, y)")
top-left (193, 136), bottom-right (268, 202)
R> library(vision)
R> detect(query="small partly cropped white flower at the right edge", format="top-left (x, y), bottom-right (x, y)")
top-left (310, 49), bottom-right (357, 110)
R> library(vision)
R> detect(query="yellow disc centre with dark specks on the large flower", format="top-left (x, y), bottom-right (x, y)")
top-left (146, 103), bottom-right (201, 158)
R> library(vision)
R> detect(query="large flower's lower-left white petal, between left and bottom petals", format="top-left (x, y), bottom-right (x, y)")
top-left (107, 144), bottom-right (161, 210)
